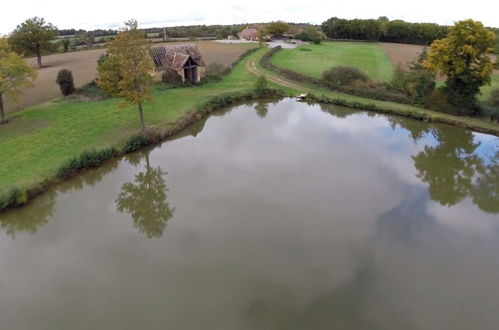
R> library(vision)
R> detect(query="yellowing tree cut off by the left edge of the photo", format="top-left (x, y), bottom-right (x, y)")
top-left (0, 38), bottom-right (36, 123)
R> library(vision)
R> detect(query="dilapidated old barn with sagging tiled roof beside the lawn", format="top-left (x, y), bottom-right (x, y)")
top-left (151, 44), bottom-right (206, 84)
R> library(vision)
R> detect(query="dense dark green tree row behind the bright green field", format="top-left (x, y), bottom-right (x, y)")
top-left (322, 17), bottom-right (449, 45)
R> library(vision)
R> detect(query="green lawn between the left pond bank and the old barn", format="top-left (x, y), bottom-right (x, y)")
top-left (0, 49), bottom-right (266, 193)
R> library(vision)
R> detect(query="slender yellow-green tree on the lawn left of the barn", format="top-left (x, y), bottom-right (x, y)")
top-left (96, 19), bottom-right (154, 131)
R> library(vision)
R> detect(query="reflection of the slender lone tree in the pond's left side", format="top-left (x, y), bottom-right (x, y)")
top-left (115, 153), bottom-right (175, 238)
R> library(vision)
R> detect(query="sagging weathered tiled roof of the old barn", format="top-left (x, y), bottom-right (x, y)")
top-left (151, 44), bottom-right (205, 70)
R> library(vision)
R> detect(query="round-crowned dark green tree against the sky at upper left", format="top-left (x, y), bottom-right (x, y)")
top-left (9, 17), bottom-right (57, 67)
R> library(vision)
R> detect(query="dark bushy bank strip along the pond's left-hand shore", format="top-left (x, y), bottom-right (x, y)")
top-left (0, 88), bottom-right (287, 214)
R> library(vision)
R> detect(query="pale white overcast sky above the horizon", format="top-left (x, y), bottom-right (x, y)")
top-left (0, 0), bottom-right (499, 34)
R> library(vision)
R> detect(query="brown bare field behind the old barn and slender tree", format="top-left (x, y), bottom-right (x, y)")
top-left (5, 41), bottom-right (256, 112)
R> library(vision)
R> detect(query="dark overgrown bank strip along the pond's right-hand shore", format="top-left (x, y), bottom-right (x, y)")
top-left (304, 93), bottom-right (499, 136)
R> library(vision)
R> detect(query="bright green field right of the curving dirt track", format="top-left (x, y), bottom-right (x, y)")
top-left (271, 42), bottom-right (394, 81)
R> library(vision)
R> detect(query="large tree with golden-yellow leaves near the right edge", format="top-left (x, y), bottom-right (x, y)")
top-left (423, 19), bottom-right (495, 115)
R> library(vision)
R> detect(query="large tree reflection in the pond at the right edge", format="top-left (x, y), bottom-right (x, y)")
top-left (412, 127), bottom-right (499, 213)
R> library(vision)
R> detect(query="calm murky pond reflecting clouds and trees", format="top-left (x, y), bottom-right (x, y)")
top-left (0, 99), bottom-right (499, 330)
